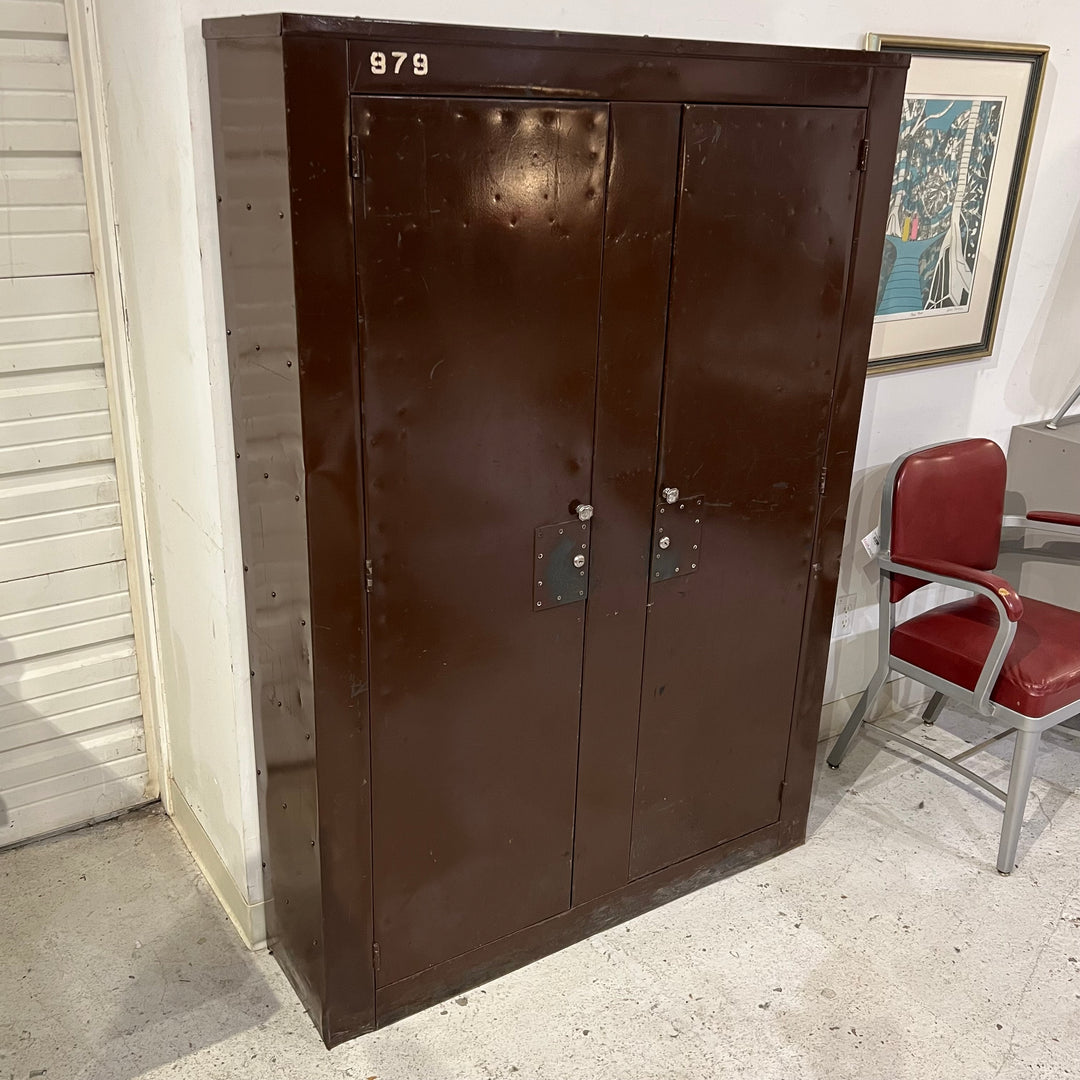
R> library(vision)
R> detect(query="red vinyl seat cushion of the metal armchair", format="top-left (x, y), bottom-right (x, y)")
top-left (892, 596), bottom-right (1080, 716)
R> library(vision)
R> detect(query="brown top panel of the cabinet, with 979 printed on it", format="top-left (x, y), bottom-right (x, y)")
top-left (203, 14), bottom-right (909, 108)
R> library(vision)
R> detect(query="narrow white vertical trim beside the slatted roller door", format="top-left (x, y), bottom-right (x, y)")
top-left (64, 0), bottom-right (173, 813)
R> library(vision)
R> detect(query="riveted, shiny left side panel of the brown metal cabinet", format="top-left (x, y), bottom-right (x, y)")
top-left (207, 38), bottom-right (324, 1026)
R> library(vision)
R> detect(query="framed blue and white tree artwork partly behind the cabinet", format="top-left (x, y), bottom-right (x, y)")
top-left (866, 33), bottom-right (1050, 374)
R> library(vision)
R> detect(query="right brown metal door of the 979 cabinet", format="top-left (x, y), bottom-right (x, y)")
top-left (630, 105), bottom-right (865, 877)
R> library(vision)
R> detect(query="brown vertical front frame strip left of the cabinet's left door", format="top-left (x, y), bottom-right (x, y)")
top-left (284, 37), bottom-right (375, 1044)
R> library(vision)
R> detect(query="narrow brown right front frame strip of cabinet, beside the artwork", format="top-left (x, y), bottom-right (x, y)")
top-left (780, 68), bottom-right (907, 847)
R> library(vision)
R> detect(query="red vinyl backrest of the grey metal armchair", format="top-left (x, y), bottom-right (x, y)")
top-left (882, 438), bottom-right (1005, 604)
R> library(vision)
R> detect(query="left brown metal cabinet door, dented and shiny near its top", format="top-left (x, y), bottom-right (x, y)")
top-left (352, 97), bottom-right (608, 985)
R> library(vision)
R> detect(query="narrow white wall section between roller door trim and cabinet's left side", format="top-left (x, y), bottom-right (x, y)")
top-left (95, 0), bottom-right (265, 939)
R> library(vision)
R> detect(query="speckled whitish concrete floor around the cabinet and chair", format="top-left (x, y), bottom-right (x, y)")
top-left (0, 712), bottom-right (1080, 1080)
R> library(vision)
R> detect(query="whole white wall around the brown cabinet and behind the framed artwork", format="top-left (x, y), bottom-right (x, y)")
top-left (96, 0), bottom-right (1080, 941)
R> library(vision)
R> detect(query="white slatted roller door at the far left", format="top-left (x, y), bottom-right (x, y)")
top-left (0, 0), bottom-right (148, 847)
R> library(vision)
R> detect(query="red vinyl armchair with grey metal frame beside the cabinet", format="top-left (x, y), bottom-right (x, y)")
top-left (828, 438), bottom-right (1080, 874)
